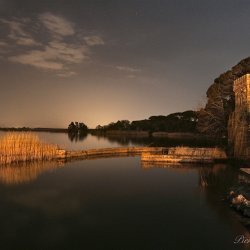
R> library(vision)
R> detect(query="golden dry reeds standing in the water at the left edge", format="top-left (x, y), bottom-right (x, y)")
top-left (0, 132), bottom-right (58, 164)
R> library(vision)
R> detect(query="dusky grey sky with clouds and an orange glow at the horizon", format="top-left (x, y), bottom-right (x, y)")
top-left (0, 0), bottom-right (250, 128)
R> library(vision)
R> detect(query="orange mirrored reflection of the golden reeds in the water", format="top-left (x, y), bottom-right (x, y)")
top-left (0, 161), bottom-right (64, 185)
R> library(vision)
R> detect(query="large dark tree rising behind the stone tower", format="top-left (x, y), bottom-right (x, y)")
top-left (197, 57), bottom-right (250, 138)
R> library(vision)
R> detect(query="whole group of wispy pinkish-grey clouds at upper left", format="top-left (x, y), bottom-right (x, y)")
top-left (0, 13), bottom-right (104, 77)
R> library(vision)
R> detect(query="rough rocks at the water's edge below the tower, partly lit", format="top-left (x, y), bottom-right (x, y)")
top-left (228, 183), bottom-right (250, 226)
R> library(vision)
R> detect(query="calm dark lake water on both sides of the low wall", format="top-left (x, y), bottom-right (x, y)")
top-left (0, 132), bottom-right (250, 250)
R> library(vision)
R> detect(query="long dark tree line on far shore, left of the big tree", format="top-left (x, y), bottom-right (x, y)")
top-left (96, 110), bottom-right (197, 132)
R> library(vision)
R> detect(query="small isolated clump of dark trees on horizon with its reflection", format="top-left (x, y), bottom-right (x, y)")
top-left (68, 122), bottom-right (88, 141)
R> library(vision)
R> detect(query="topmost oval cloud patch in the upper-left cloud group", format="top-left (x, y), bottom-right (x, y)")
top-left (39, 12), bottom-right (75, 36)
